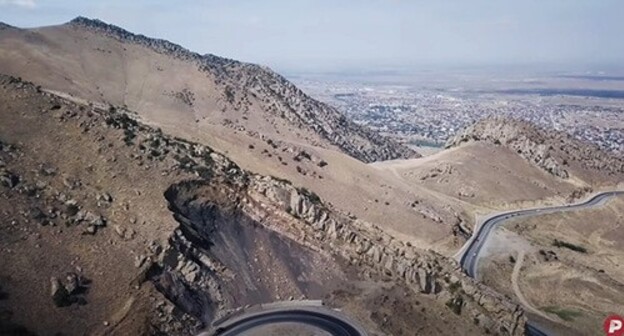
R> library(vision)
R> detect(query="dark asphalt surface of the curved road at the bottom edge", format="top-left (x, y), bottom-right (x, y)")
top-left (215, 310), bottom-right (366, 336)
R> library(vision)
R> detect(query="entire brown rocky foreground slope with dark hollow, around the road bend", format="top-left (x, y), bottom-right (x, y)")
top-left (0, 77), bottom-right (525, 335)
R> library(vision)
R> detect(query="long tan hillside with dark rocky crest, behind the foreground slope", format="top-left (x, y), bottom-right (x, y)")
top-left (0, 18), bottom-right (472, 254)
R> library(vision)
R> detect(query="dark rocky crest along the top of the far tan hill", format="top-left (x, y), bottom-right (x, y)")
top-left (70, 17), bottom-right (419, 162)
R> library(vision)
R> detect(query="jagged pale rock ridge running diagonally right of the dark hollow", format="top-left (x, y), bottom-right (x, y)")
top-left (246, 176), bottom-right (526, 335)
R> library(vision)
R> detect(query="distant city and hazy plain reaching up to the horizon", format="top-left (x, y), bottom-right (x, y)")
top-left (292, 76), bottom-right (624, 155)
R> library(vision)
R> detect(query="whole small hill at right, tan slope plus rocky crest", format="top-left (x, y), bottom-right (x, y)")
top-left (372, 118), bottom-right (624, 244)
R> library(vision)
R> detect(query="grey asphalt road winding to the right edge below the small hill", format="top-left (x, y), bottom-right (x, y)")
top-left (460, 191), bottom-right (624, 336)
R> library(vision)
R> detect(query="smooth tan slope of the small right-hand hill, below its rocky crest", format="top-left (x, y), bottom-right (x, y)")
top-left (375, 141), bottom-right (576, 211)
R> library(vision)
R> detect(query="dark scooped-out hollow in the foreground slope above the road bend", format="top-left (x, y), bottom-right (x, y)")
top-left (151, 181), bottom-right (344, 322)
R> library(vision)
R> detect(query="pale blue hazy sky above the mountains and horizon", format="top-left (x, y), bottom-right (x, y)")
top-left (0, 0), bottom-right (624, 70)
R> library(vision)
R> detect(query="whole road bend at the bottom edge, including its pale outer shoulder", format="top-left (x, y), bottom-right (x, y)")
top-left (207, 307), bottom-right (367, 336)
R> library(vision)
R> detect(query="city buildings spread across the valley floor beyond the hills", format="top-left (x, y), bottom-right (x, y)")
top-left (299, 78), bottom-right (624, 154)
